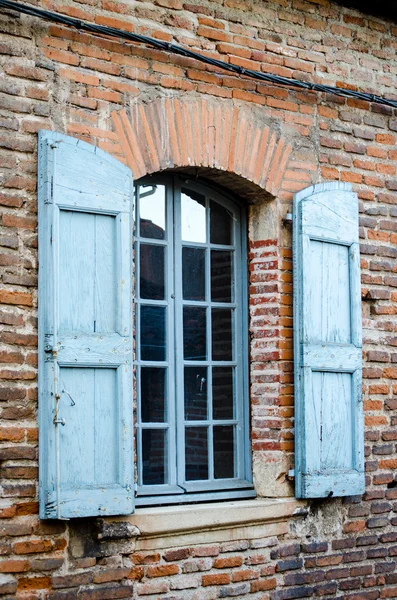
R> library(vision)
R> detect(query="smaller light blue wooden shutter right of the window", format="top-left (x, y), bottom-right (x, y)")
top-left (293, 182), bottom-right (365, 498)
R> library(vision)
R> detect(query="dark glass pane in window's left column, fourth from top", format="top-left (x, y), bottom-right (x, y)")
top-left (141, 367), bottom-right (167, 423)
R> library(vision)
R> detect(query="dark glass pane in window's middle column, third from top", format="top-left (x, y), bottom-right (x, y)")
top-left (183, 306), bottom-right (207, 360)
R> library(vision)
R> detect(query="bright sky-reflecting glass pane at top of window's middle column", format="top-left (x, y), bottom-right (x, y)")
top-left (181, 188), bottom-right (207, 244)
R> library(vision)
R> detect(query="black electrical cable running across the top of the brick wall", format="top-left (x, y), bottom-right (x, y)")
top-left (0, 0), bottom-right (397, 108)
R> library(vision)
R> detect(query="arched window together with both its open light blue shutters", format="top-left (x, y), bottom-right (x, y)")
top-left (38, 131), bottom-right (365, 519)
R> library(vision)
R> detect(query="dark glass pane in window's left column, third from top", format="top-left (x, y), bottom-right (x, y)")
top-left (141, 306), bottom-right (166, 361)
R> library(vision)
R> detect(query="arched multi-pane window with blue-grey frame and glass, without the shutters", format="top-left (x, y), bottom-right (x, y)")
top-left (134, 178), bottom-right (251, 503)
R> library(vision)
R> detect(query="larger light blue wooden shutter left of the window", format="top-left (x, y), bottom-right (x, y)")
top-left (38, 131), bottom-right (134, 518)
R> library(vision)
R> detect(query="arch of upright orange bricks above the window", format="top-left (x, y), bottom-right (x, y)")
top-left (112, 97), bottom-right (300, 196)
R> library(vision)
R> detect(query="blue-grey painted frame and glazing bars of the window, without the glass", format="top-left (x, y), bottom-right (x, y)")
top-left (133, 174), bottom-right (256, 506)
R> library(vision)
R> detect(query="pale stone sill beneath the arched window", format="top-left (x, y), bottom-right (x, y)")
top-left (106, 498), bottom-right (307, 550)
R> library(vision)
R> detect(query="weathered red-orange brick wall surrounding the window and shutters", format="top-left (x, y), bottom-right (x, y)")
top-left (0, 0), bottom-right (397, 600)
